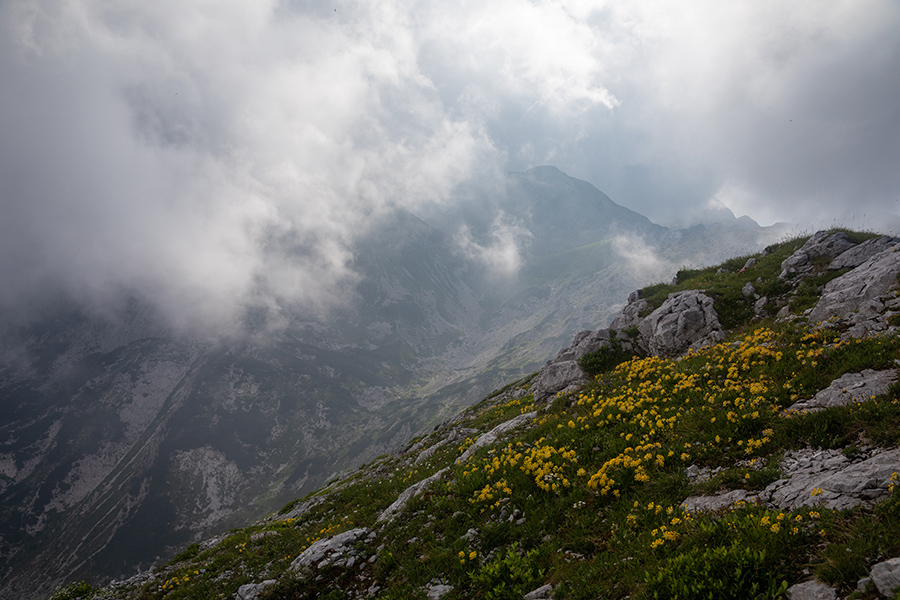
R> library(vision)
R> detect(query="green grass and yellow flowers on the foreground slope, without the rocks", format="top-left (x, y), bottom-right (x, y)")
top-left (55, 233), bottom-right (900, 600)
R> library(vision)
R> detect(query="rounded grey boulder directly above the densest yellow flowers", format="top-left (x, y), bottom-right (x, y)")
top-left (638, 290), bottom-right (725, 356)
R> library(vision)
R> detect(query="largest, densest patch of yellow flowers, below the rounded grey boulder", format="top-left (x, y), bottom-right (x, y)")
top-left (569, 327), bottom-right (784, 495)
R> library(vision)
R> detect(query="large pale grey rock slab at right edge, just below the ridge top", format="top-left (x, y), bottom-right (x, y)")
top-left (809, 245), bottom-right (900, 325)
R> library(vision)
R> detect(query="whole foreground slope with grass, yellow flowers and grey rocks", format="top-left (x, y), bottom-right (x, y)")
top-left (53, 231), bottom-right (900, 600)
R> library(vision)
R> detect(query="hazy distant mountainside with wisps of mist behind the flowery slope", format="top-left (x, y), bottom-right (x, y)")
top-left (0, 167), bottom-right (784, 598)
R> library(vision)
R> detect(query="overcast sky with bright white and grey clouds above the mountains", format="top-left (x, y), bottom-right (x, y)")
top-left (0, 0), bottom-right (900, 328)
